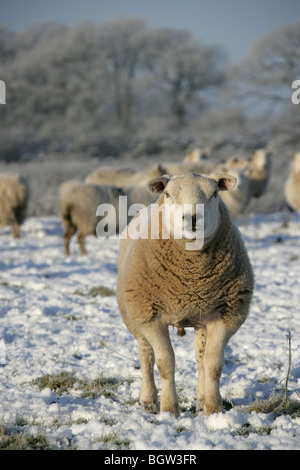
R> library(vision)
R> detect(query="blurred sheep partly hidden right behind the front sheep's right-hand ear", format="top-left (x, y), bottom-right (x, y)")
top-left (215, 165), bottom-right (250, 219)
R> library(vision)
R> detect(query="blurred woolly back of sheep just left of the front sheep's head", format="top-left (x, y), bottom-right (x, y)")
top-left (85, 165), bottom-right (166, 187)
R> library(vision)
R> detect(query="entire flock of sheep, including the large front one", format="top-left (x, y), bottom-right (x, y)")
top-left (0, 150), bottom-right (300, 416)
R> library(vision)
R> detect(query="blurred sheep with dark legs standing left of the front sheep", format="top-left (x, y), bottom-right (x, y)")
top-left (60, 180), bottom-right (125, 255)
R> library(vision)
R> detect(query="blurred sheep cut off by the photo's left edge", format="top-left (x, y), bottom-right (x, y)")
top-left (0, 173), bottom-right (29, 238)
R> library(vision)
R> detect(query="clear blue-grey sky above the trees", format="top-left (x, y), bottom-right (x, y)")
top-left (0, 0), bottom-right (300, 62)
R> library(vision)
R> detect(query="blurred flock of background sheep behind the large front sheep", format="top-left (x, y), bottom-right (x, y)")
top-left (0, 149), bottom-right (300, 254)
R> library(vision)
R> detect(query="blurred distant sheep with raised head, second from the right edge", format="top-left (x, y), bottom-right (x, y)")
top-left (249, 149), bottom-right (273, 198)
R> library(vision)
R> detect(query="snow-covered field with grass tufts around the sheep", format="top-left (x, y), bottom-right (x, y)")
top-left (0, 214), bottom-right (300, 450)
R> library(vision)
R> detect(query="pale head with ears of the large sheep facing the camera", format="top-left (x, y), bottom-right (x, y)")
top-left (148, 173), bottom-right (236, 246)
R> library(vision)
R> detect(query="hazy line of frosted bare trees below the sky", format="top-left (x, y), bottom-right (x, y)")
top-left (0, 18), bottom-right (300, 160)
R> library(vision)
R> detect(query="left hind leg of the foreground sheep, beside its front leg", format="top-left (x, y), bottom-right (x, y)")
top-left (138, 335), bottom-right (158, 413)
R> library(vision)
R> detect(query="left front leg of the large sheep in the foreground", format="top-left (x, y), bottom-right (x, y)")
top-left (143, 323), bottom-right (178, 415)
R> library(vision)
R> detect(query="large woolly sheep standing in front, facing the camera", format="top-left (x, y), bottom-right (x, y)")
top-left (117, 174), bottom-right (254, 416)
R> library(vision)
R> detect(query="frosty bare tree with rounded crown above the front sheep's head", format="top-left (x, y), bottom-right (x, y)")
top-left (146, 28), bottom-right (225, 125)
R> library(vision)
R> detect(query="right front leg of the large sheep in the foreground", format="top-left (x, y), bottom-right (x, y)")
top-left (203, 320), bottom-right (232, 415)
